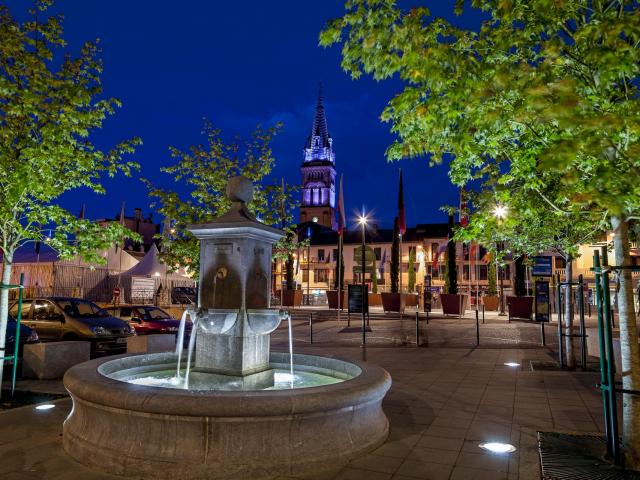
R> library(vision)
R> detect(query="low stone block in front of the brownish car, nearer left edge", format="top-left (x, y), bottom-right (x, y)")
top-left (22, 341), bottom-right (91, 380)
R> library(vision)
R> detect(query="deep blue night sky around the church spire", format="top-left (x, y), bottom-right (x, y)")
top-left (5, 0), bottom-right (480, 226)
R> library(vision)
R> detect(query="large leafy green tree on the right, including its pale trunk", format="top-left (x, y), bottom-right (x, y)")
top-left (321, 0), bottom-right (640, 468)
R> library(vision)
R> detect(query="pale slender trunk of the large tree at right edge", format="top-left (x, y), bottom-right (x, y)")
top-left (611, 217), bottom-right (640, 470)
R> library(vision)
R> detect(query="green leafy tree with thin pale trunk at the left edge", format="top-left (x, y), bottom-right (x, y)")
top-left (0, 1), bottom-right (140, 390)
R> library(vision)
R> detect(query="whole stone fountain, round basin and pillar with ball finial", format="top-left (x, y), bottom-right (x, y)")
top-left (63, 177), bottom-right (391, 480)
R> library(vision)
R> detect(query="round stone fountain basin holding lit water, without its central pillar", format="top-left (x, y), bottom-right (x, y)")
top-left (63, 352), bottom-right (391, 480)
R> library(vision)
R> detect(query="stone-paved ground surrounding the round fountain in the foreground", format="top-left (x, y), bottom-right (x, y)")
top-left (0, 339), bottom-right (602, 480)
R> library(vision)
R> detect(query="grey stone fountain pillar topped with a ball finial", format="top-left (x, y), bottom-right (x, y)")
top-left (189, 177), bottom-right (284, 381)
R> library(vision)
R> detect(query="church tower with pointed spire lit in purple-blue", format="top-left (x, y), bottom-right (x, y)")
top-left (300, 86), bottom-right (336, 228)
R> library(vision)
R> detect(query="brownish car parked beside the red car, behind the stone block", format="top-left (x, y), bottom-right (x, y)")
top-left (9, 297), bottom-right (135, 353)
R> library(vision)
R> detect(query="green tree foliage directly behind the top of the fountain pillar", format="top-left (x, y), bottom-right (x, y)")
top-left (145, 120), bottom-right (306, 276)
